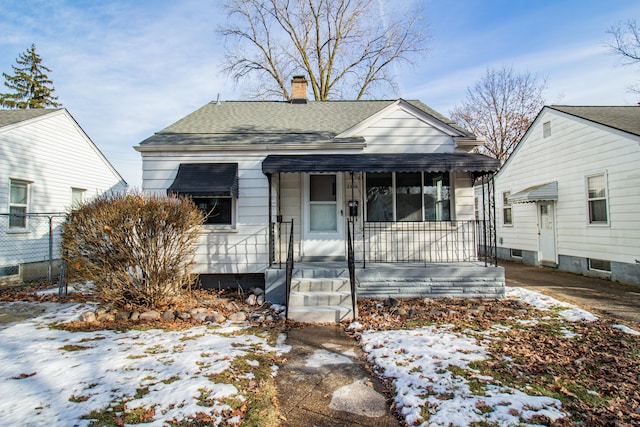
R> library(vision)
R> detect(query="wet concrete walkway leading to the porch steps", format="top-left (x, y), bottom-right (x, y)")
top-left (276, 325), bottom-right (400, 427)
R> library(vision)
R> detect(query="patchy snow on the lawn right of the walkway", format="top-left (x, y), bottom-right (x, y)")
top-left (358, 287), bottom-right (608, 426)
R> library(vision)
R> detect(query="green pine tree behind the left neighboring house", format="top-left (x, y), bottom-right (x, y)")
top-left (0, 44), bottom-right (62, 109)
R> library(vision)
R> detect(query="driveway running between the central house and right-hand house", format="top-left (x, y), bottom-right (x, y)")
top-left (499, 261), bottom-right (640, 328)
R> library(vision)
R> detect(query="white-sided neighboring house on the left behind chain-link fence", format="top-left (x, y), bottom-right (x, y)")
top-left (0, 108), bottom-right (126, 282)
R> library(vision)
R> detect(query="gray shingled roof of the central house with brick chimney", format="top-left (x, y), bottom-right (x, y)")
top-left (140, 100), bottom-right (472, 145)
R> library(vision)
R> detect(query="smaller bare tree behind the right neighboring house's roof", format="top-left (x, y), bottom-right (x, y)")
top-left (450, 67), bottom-right (547, 163)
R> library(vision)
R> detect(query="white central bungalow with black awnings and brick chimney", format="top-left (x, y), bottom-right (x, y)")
top-left (135, 76), bottom-right (504, 321)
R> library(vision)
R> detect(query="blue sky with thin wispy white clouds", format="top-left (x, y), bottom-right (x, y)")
top-left (0, 0), bottom-right (640, 187)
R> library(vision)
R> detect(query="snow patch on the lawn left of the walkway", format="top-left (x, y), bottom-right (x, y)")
top-left (0, 305), bottom-right (286, 426)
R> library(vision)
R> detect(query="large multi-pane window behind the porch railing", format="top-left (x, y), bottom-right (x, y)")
top-left (366, 172), bottom-right (451, 222)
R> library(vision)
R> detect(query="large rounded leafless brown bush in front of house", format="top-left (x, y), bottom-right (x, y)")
top-left (62, 193), bottom-right (204, 307)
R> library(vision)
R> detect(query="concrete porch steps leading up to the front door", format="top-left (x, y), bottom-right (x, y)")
top-left (288, 276), bottom-right (353, 323)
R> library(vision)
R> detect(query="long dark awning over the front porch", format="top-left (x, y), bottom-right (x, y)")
top-left (262, 153), bottom-right (500, 175)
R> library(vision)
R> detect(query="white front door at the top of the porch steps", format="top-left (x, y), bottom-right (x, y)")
top-left (302, 174), bottom-right (345, 258)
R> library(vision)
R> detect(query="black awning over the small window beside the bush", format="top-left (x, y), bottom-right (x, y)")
top-left (167, 163), bottom-right (238, 197)
